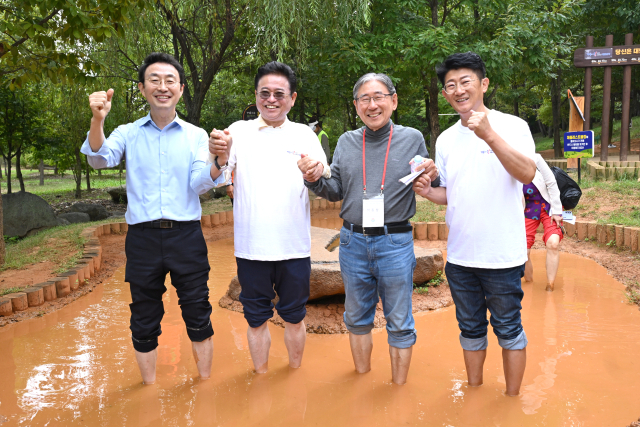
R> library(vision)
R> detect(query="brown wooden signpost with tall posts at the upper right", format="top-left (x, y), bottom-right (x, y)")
top-left (573, 33), bottom-right (640, 161)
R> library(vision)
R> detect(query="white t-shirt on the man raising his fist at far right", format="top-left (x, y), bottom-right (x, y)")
top-left (436, 110), bottom-right (535, 268)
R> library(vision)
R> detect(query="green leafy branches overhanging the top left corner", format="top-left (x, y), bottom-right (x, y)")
top-left (0, 0), bottom-right (146, 88)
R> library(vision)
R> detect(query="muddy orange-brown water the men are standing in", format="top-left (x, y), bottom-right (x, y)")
top-left (0, 227), bottom-right (640, 427)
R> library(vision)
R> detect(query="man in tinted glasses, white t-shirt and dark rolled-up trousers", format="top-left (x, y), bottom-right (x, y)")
top-left (209, 61), bottom-right (331, 373)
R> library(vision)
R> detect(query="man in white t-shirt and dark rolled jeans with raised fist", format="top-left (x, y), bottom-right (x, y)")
top-left (413, 52), bottom-right (536, 396)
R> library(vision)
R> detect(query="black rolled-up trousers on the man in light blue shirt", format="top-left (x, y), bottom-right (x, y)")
top-left (125, 221), bottom-right (213, 353)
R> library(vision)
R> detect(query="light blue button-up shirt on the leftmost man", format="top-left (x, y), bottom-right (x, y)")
top-left (80, 114), bottom-right (224, 224)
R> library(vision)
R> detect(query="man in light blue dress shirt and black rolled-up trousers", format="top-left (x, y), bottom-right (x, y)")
top-left (81, 53), bottom-right (228, 384)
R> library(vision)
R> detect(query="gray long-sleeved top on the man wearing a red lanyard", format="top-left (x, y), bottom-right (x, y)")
top-left (305, 120), bottom-right (439, 225)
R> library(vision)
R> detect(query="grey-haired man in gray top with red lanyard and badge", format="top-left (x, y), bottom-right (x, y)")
top-left (298, 73), bottom-right (437, 384)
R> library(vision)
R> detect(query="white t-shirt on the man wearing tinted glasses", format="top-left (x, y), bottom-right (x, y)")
top-left (229, 118), bottom-right (329, 261)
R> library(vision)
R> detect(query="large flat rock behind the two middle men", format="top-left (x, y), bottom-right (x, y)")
top-left (222, 227), bottom-right (444, 301)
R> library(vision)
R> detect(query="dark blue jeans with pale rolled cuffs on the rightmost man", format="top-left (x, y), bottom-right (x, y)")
top-left (444, 262), bottom-right (527, 351)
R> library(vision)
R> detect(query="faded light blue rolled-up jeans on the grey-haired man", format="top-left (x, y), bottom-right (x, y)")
top-left (340, 227), bottom-right (416, 348)
